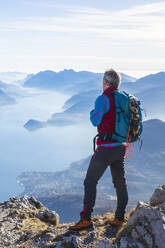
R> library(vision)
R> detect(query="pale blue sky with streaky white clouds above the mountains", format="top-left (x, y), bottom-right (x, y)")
top-left (0, 0), bottom-right (165, 77)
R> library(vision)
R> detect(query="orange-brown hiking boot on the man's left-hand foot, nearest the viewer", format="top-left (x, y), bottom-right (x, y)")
top-left (69, 219), bottom-right (94, 232)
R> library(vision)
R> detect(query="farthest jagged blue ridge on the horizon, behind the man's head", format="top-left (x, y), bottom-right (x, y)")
top-left (24, 69), bottom-right (136, 94)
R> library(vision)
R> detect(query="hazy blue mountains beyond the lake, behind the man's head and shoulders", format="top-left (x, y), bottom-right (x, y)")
top-left (24, 70), bottom-right (165, 131)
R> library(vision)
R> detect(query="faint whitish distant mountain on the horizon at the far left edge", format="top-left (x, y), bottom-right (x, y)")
top-left (0, 72), bottom-right (28, 83)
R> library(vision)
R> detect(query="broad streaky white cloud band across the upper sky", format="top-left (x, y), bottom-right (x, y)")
top-left (0, 2), bottom-right (165, 44)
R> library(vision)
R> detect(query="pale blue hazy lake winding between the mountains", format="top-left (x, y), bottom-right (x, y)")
top-left (0, 88), bottom-right (96, 201)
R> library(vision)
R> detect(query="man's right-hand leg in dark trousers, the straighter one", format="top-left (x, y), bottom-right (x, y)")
top-left (110, 148), bottom-right (128, 221)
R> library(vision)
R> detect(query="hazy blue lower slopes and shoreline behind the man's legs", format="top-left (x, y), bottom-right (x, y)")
top-left (18, 119), bottom-right (165, 222)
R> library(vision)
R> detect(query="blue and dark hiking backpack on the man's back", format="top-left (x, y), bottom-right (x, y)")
top-left (111, 91), bottom-right (143, 143)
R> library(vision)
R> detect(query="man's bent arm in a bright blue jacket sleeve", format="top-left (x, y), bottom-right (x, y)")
top-left (90, 95), bottom-right (110, 126)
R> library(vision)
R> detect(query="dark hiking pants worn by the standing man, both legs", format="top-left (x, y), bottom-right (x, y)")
top-left (80, 145), bottom-right (128, 220)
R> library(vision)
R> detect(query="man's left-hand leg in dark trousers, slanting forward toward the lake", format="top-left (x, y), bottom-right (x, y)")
top-left (81, 147), bottom-right (108, 219)
